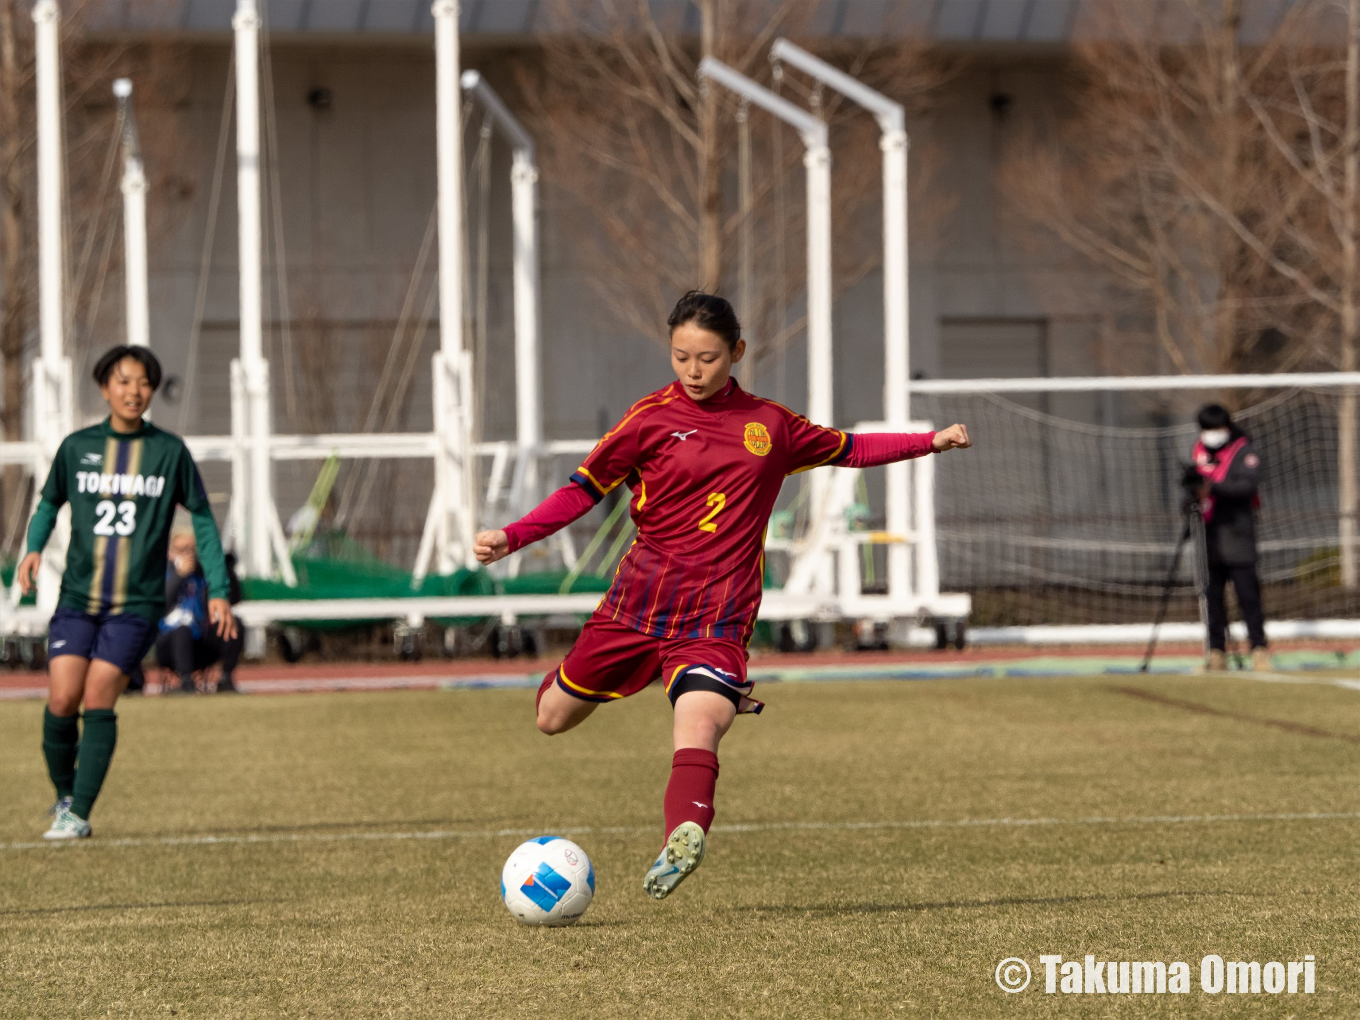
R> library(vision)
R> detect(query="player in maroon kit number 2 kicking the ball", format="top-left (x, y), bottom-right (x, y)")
top-left (476, 291), bottom-right (972, 899)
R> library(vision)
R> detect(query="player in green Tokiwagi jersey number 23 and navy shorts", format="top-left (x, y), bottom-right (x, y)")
top-left (19, 347), bottom-right (237, 839)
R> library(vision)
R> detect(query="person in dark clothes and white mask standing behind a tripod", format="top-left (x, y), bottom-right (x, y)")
top-left (1187, 404), bottom-right (1270, 672)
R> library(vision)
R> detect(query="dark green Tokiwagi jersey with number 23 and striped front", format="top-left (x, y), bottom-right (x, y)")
top-left (29, 419), bottom-right (227, 620)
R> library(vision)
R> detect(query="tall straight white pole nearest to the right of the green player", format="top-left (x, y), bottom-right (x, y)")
top-left (231, 0), bottom-right (273, 577)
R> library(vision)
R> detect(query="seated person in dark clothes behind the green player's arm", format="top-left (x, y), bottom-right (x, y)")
top-left (156, 529), bottom-right (242, 694)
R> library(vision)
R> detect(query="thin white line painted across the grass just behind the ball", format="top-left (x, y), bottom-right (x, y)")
top-left (0, 811), bottom-right (1360, 851)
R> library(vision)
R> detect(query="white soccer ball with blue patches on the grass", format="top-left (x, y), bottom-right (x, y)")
top-left (500, 836), bottom-right (594, 928)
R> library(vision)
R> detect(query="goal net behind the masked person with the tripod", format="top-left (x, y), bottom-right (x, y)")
top-left (911, 377), bottom-right (1360, 636)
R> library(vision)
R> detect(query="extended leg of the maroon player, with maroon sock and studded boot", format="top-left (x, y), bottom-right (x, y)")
top-left (642, 681), bottom-right (737, 899)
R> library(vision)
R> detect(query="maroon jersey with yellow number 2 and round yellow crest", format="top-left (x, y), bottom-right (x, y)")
top-left (571, 381), bottom-right (854, 643)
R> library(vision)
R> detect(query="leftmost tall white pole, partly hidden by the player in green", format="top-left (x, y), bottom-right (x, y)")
top-left (29, 0), bottom-right (75, 612)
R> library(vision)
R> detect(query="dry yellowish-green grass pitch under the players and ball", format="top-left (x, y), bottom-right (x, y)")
top-left (0, 677), bottom-right (1360, 1020)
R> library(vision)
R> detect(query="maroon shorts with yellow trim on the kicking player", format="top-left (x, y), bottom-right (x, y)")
top-left (549, 613), bottom-right (752, 711)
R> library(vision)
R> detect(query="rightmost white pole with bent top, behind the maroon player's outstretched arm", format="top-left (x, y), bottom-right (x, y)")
top-left (770, 38), bottom-right (911, 606)
